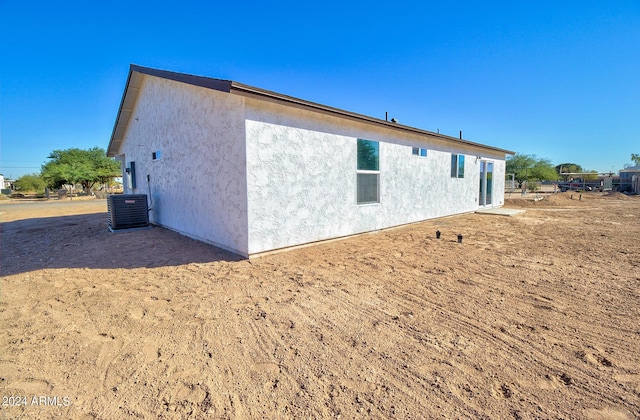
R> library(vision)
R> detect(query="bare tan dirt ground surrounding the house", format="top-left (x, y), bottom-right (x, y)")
top-left (0, 193), bottom-right (640, 419)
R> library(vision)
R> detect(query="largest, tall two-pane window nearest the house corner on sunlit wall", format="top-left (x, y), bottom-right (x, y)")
top-left (356, 139), bottom-right (380, 204)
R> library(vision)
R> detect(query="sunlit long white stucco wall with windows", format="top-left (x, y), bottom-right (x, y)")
top-left (246, 99), bottom-right (504, 254)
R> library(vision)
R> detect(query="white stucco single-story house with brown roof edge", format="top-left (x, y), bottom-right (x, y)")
top-left (107, 65), bottom-right (513, 257)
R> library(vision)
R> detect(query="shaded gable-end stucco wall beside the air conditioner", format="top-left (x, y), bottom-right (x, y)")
top-left (114, 76), bottom-right (248, 255)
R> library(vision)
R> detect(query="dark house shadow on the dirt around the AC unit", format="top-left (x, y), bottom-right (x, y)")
top-left (0, 213), bottom-right (243, 276)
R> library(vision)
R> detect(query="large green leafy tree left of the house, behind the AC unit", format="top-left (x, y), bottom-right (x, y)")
top-left (42, 147), bottom-right (120, 193)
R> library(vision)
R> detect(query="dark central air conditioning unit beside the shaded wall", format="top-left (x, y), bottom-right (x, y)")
top-left (107, 194), bottom-right (149, 231)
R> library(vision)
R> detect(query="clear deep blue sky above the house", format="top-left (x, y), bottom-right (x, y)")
top-left (0, 0), bottom-right (640, 178)
